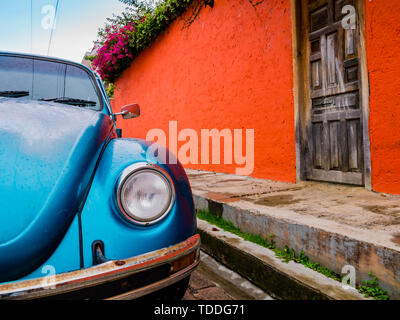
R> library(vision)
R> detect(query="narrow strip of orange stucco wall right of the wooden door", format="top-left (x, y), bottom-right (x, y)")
top-left (365, 0), bottom-right (400, 194)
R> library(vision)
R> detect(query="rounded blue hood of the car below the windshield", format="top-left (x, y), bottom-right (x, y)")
top-left (0, 98), bottom-right (112, 282)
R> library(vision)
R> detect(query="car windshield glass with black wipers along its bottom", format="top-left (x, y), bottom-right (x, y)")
top-left (0, 55), bottom-right (100, 110)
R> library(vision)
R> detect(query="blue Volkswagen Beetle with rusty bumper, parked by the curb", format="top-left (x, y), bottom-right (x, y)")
top-left (0, 52), bottom-right (200, 299)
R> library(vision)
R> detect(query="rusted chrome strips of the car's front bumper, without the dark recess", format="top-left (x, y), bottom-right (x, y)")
top-left (0, 234), bottom-right (200, 300)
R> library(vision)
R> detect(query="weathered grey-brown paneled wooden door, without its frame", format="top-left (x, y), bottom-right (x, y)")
top-left (302, 0), bottom-right (364, 185)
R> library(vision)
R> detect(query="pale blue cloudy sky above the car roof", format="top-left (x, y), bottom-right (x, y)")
top-left (0, 0), bottom-right (126, 62)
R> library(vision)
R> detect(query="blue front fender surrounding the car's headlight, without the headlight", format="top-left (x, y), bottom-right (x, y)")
top-left (81, 139), bottom-right (196, 268)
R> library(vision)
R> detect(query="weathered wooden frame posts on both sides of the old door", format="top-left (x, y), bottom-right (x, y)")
top-left (290, 0), bottom-right (372, 190)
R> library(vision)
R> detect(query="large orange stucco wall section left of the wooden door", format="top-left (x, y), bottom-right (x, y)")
top-left (113, 0), bottom-right (296, 182)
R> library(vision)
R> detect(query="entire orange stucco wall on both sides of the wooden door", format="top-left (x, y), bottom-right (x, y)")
top-left (113, 0), bottom-right (400, 194)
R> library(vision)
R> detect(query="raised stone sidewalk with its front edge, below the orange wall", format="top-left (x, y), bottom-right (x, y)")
top-left (186, 170), bottom-right (400, 299)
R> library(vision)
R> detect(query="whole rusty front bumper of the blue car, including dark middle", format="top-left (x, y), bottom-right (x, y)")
top-left (0, 234), bottom-right (200, 300)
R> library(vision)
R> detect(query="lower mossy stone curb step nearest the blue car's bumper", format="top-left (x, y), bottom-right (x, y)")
top-left (197, 219), bottom-right (367, 300)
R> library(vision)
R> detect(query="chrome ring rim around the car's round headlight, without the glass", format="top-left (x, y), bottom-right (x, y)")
top-left (117, 162), bottom-right (175, 226)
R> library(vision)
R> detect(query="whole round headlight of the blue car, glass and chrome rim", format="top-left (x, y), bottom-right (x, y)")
top-left (118, 165), bottom-right (174, 224)
